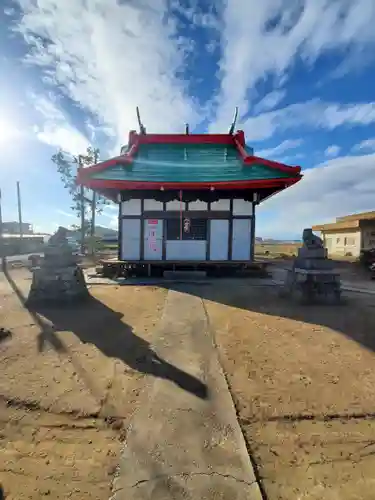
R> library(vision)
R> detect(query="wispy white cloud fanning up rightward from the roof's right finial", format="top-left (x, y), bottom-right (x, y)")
top-left (212, 0), bottom-right (375, 130)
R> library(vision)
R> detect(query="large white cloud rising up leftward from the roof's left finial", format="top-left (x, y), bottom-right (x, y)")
top-left (18, 0), bottom-right (203, 152)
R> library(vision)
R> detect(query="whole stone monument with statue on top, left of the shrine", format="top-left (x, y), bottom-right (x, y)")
top-left (27, 227), bottom-right (88, 304)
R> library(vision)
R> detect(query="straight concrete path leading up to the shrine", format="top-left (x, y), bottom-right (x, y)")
top-left (112, 286), bottom-right (261, 500)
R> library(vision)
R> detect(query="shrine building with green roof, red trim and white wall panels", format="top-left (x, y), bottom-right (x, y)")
top-left (77, 129), bottom-right (302, 268)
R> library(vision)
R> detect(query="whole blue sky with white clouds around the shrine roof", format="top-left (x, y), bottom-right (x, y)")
top-left (0, 0), bottom-right (375, 238)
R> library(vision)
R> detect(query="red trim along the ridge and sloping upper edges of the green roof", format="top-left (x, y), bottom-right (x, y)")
top-left (77, 130), bottom-right (301, 185)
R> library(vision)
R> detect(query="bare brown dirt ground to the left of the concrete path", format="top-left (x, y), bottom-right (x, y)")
top-left (0, 269), bottom-right (166, 500)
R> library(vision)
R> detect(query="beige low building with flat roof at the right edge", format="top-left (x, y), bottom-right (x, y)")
top-left (312, 211), bottom-right (375, 257)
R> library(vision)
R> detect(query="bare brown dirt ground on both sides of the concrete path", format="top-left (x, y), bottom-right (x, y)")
top-left (0, 269), bottom-right (375, 500)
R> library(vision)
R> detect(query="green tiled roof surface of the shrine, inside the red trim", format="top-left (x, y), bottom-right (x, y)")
top-left (91, 144), bottom-right (294, 182)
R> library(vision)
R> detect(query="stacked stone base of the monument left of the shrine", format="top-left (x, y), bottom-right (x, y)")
top-left (27, 265), bottom-right (88, 304)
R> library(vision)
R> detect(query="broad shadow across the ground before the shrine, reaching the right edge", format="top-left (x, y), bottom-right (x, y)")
top-left (166, 280), bottom-right (375, 352)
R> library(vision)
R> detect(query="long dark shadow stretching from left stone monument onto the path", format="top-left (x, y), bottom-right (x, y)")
top-left (5, 272), bottom-right (208, 399)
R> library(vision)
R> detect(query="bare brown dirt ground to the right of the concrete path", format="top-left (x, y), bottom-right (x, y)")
top-left (201, 286), bottom-right (375, 500)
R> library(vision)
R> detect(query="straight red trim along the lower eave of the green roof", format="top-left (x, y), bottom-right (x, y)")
top-left (78, 176), bottom-right (301, 191)
